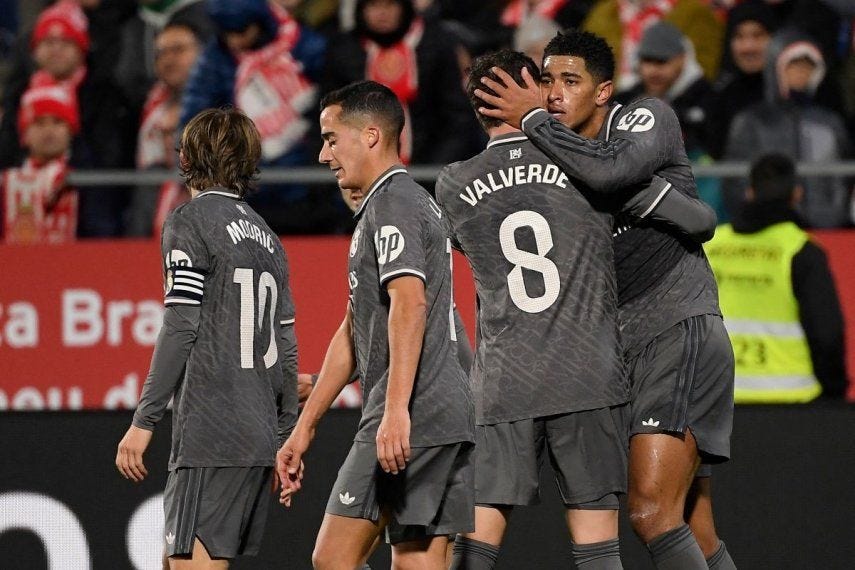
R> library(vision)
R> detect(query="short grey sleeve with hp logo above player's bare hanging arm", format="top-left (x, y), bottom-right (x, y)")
top-left (372, 191), bottom-right (428, 286)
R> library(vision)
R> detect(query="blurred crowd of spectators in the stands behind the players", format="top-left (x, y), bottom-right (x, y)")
top-left (0, 0), bottom-right (855, 237)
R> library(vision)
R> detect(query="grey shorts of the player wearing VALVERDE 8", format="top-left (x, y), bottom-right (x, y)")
top-left (475, 405), bottom-right (628, 510)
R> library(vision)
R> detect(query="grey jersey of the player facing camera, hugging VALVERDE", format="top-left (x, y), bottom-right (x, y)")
top-left (523, 98), bottom-right (720, 355)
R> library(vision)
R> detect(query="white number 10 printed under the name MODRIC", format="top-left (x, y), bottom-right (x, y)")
top-left (233, 267), bottom-right (279, 368)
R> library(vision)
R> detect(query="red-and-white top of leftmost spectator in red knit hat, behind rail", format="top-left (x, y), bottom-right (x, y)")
top-left (3, 157), bottom-right (77, 244)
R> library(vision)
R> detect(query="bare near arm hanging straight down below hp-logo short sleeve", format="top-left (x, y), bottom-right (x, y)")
top-left (377, 275), bottom-right (427, 474)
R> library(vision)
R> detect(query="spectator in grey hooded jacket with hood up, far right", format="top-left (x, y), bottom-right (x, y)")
top-left (723, 29), bottom-right (852, 227)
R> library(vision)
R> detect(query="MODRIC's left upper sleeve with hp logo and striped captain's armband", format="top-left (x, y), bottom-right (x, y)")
top-left (161, 208), bottom-right (210, 306)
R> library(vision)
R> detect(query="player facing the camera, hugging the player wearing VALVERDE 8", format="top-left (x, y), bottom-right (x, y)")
top-left (478, 32), bottom-right (733, 570)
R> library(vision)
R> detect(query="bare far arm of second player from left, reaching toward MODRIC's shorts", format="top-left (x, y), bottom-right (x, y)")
top-left (276, 306), bottom-right (356, 506)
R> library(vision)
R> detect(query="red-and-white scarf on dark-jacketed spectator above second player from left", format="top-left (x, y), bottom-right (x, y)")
top-left (362, 18), bottom-right (424, 164)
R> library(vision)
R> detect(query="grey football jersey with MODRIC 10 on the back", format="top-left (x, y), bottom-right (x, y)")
top-left (161, 189), bottom-right (296, 469)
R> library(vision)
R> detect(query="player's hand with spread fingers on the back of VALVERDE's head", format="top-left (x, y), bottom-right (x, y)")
top-left (475, 67), bottom-right (543, 128)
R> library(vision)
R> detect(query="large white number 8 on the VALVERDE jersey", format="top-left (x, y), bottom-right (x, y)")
top-left (499, 210), bottom-right (561, 313)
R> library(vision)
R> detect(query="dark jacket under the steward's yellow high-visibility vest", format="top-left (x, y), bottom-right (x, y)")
top-left (733, 203), bottom-right (848, 398)
